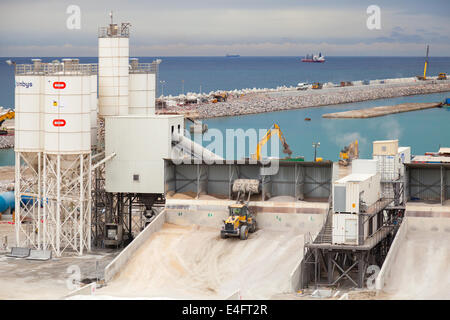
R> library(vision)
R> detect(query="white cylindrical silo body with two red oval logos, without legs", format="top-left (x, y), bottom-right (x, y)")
top-left (44, 75), bottom-right (92, 154)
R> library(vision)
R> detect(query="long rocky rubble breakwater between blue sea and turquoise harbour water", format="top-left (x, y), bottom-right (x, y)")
top-left (166, 81), bottom-right (450, 119)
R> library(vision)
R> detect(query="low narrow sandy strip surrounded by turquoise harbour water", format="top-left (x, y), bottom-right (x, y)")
top-left (322, 102), bottom-right (441, 119)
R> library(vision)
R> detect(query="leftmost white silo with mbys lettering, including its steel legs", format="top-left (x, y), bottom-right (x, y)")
top-left (14, 59), bottom-right (45, 248)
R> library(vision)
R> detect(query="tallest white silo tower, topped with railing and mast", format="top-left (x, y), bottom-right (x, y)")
top-left (98, 14), bottom-right (130, 117)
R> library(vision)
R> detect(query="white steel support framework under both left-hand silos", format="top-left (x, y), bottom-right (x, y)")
top-left (15, 152), bottom-right (91, 256)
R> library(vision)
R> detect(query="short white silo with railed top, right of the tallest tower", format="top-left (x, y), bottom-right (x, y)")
top-left (129, 58), bottom-right (161, 116)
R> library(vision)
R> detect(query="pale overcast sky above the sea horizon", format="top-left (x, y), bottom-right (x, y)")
top-left (0, 0), bottom-right (450, 56)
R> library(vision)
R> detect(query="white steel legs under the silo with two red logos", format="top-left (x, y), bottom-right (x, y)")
top-left (43, 153), bottom-right (91, 256)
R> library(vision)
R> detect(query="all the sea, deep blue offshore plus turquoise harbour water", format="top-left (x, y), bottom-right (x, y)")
top-left (0, 57), bottom-right (450, 165)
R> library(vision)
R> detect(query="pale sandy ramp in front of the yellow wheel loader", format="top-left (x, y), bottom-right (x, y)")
top-left (96, 224), bottom-right (304, 299)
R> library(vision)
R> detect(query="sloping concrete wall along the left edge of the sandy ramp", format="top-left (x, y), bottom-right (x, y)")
top-left (105, 210), bottom-right (166, 282)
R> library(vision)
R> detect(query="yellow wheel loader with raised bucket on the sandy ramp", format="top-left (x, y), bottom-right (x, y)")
top-left (220, 179), bottom-right (260, 240)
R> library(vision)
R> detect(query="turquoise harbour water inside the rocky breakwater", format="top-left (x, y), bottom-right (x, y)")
top-left (204, 92), bottom-right (450, 161)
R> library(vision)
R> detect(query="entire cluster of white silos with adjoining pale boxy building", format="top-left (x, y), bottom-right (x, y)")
top-left (11, 18), bottom-right (176, 256)
